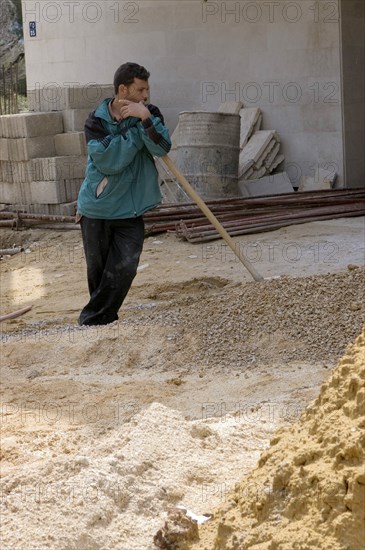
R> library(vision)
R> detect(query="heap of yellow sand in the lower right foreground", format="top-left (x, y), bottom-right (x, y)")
top-left (165, 331), bottom-right (365, 550)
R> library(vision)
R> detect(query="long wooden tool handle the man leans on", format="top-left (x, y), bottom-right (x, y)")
top-left (161, 155), bottom-right (264, 281)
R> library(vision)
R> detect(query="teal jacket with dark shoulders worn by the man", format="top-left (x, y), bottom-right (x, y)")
top-left (77, 98), bottom-right (171, 219)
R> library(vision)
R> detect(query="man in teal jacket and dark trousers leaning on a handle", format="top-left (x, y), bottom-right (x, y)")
top-left (77, 63), bottom-right (171, 325)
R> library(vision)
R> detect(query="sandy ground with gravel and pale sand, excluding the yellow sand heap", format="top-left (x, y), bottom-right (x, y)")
top-left (0, 218), bottom-right (365, 550)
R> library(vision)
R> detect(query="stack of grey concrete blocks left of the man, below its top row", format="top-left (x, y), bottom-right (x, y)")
top-left (0, 112), bottom-right (87, 215)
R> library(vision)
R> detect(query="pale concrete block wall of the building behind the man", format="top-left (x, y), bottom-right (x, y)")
top-left (23, 0), bottom-right (343, 185)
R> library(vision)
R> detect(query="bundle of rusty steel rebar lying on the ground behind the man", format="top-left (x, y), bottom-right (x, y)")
top-left (0, 188), bottom-right (365, 243)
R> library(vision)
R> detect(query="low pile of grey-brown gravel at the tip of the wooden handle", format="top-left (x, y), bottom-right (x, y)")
top-left (124, 268), bottom-right (365, 368)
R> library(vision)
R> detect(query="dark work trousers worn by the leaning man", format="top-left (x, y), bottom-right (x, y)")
top-left (79, 216), bottom-right (144, 325)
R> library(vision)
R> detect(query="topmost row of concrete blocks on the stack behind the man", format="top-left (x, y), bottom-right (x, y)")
top-left (28, 84), bottom-right (114, 112)
